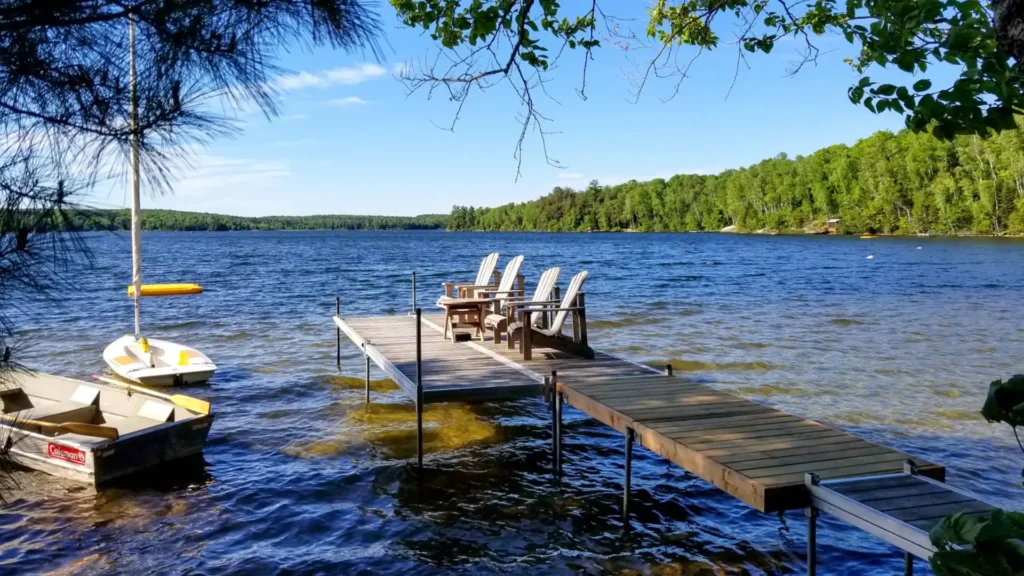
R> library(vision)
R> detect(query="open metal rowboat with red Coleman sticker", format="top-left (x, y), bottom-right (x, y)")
top-left (0, 366), bottom-right (213, 485)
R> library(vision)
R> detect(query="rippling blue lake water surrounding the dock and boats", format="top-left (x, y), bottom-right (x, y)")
top-left (0, 232), bottom-right (1024, 575)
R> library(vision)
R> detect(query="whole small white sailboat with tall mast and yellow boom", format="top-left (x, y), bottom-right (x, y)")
top-left (103, 17), bottom-right (217, 386)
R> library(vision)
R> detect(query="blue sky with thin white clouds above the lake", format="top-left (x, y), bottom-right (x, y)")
top-left (92, 2), bottom-right (921, 215)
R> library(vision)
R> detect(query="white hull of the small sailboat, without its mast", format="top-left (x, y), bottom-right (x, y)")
top-left (103, 335), bottom-right (217, 386)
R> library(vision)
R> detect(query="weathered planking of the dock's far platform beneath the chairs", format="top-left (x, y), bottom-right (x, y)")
top-left (334, 314), bottom-right (659, 404)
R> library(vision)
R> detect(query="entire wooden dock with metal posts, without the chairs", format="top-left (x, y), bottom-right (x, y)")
top-left (334, 303), bottom-right (992, 574)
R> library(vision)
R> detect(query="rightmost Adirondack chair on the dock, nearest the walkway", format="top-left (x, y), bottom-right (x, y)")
top-left (508, 271), bottom-right (594, 361)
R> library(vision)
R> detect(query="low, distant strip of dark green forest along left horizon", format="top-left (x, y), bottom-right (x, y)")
top-left (62, 209), bottom-right (447, 232)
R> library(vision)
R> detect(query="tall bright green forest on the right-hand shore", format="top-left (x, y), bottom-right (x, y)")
top-left (449, 118), bottom-right (1024, 234)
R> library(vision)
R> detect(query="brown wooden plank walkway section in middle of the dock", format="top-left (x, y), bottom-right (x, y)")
top-left (557, 376), bottom-right (945, 512)
